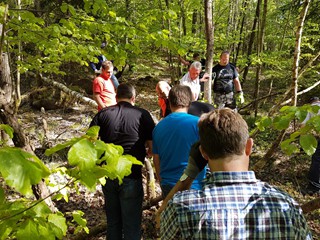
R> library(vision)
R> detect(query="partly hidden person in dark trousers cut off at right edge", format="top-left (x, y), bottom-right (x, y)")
top-left (302, 97), bottom-right (320, 196)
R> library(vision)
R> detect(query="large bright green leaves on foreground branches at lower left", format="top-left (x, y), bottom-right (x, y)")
top-left (0, 125), bottom-right (142, 240)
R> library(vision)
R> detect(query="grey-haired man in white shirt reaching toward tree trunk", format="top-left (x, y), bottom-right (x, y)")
top-left (180, 61), bottom-right (209, 101)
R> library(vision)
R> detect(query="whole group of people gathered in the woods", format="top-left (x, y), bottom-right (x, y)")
top-left (90, 51), bottom-right (319, 240)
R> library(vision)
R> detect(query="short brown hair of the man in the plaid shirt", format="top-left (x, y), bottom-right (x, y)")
top-left (198, 108), bottom-right (249, 159)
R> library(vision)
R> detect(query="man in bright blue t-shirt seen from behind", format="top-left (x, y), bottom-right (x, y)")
top-left (152, 85), bottom-right (205, 197)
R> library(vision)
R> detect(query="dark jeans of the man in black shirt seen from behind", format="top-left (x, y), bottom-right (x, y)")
top-left (102, 178), bottom-right (143, 240)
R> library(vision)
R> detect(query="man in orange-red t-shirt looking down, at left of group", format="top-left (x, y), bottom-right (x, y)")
top-left (93, 61), bottom-right (117, 111)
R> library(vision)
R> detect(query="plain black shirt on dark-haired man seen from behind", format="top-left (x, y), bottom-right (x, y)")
top-left (90, 102), bottom-right (155, 179)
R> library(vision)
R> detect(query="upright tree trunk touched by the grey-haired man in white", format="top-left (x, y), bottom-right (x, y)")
top-left (204, 0), bottom-right (214, 103)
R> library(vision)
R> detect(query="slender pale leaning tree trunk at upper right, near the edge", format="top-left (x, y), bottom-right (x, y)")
top-left (291, 0), bottom-right (311, 106)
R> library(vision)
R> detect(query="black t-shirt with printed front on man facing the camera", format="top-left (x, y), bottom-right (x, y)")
top-left (212, 63), bottom-right (239, 93)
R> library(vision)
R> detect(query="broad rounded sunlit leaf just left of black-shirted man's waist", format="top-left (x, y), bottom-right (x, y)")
top-left (68, 139), bottom-right (97, 170)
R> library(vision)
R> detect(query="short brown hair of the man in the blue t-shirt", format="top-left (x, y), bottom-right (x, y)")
top-left (169, 85), bottom-right (192, 107)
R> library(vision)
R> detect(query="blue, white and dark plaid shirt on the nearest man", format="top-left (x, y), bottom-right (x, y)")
top-left (160, 171), bottom-right (312, 240)
